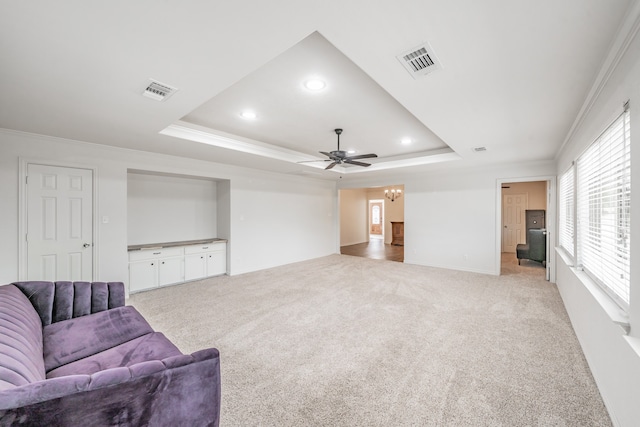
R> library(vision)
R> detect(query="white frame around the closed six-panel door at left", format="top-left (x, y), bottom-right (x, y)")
top-left (18, 157), bottom-right (100, 281)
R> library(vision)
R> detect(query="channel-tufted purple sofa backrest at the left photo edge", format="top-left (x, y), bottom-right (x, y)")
top-left (0, 285), bottom-right (45, 390)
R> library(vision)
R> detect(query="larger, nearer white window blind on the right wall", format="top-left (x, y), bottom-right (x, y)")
top-left (576, 110), bottom-right (631, 308)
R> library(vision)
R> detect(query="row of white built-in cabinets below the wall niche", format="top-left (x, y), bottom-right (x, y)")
top-left (129, 241), bottom-right (227, 293)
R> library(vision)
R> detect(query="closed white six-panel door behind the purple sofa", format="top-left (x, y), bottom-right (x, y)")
top-left (26, 164), bottom-right (93, 281)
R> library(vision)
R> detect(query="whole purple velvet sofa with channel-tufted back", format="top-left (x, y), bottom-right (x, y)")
top-left (0, 282), bottom-right (220, 427)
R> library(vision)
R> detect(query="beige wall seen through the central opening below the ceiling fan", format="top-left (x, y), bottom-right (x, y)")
top-left (340, 188), bottom-right (369, 246)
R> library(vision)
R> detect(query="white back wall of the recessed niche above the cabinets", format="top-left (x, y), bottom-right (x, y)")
top-left (127, 173), bottom-right (218, 245)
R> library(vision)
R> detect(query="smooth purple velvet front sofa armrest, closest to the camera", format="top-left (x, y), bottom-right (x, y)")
top-left (0, 348), bottom-right (220, 427)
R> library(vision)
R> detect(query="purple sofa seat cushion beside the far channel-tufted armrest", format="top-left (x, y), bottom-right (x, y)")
top-left (42, 306), bottom-right (153, 372)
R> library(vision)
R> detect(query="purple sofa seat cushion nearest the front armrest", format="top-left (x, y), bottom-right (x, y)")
top-left (47, 332), bottom-right (182, 378)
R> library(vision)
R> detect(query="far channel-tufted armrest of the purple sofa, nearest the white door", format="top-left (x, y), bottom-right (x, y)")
top-left (13, 281), bottom-right (124, 327)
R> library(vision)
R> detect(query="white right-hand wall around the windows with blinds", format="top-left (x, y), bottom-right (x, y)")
top-left (556, 17), bottom-right (640, 426)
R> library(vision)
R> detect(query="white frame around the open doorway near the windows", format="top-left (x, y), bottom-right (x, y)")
top-left (494, 175), bottom-right (557, 283)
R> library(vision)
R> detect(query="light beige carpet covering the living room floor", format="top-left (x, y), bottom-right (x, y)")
top-left (128, 255), bottom-right (611, 427)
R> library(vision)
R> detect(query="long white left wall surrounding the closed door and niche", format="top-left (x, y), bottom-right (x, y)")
top-left (0, 130), bottom-right (338, 290)
